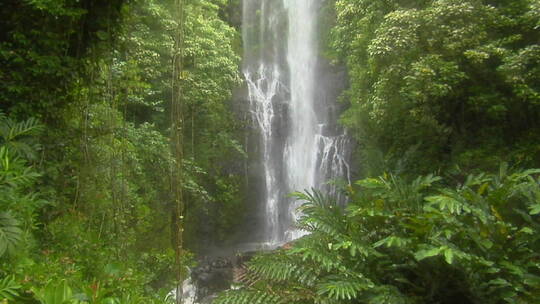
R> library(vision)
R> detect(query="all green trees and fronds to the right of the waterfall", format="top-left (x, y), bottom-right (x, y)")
top-left (217, 0), bottom-right (540, 304)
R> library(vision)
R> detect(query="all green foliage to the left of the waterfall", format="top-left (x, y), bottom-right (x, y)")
top-left (0, 0), bottom-right (245, 304)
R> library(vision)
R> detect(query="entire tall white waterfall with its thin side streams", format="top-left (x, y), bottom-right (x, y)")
top-left (243, 0), bottom-right (350, 245)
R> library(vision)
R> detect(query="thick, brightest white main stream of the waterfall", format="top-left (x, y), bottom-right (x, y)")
top-left (284, 0), bottom-right (319, 239)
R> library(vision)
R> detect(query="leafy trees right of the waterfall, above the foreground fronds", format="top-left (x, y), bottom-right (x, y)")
top-left (329, 0), bottom-right (540, 176)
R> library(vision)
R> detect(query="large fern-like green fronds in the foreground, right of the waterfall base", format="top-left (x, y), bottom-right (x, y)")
top-left (217, 165), bottom-right (540, 304)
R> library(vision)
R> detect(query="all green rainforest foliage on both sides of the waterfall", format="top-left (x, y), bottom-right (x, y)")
top-left (0, 0), bottom-right (540, 304)
